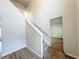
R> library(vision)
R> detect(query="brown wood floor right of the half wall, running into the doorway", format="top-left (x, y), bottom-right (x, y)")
top-left (44, 38), bottom-right (75, 59)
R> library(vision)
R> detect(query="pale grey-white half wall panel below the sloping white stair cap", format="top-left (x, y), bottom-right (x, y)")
top-left (26, 22), bottom-right (43, 57)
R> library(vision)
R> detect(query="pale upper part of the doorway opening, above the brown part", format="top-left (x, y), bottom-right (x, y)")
top-left (50, 17), bottom-right (63, 38)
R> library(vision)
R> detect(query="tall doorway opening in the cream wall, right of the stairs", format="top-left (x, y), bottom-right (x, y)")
top-left (50, 17), bottom-right (63, 50)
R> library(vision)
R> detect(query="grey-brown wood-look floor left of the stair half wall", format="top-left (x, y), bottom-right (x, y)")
top-left (2, 48), bottom-right (41, 59)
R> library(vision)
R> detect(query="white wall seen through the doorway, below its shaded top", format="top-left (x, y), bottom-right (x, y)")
top-left (50, 23), bottom-right (63, 38)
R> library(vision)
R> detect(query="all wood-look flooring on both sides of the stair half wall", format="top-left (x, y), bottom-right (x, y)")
top-left (2, 39), bottom-right (75, 59)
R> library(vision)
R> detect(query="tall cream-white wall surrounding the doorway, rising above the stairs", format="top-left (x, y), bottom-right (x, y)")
top-left (33, 0), bottom-right (78, 56)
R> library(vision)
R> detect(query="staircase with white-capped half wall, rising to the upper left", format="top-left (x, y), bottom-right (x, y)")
top-left (11, 0), bottom-right (50, 58)
